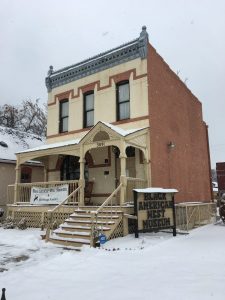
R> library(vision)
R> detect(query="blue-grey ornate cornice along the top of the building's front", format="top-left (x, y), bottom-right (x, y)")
top-left (45, 26), bottom-right (148, 92)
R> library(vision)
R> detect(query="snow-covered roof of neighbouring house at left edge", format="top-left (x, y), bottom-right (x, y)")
top-left (0, 126), bottom-right (44, 161)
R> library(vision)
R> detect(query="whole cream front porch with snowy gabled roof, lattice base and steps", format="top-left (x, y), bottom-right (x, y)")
top-left (8, 122), bottom-right (150, 243)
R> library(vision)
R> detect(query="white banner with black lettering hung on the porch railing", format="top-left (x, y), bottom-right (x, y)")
top-left (30, 184), bottom-right (68, 205)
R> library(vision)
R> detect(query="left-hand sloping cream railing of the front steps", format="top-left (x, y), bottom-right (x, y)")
top-left (46, 186), bottom-right (82, 241)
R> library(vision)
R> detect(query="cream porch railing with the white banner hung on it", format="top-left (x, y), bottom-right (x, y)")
top-left (7, 180), bottom-right (79, 204)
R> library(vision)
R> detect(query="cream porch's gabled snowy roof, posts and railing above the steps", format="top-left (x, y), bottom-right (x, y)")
top-left (8, 122), bottom-right (151, 206)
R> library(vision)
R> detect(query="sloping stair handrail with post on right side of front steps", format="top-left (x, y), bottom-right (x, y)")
top-left (90, 183), bottom-right (123, 247)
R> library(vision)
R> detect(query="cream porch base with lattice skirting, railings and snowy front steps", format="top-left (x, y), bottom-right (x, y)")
top-left (8, 176), bottom-right (146, 247)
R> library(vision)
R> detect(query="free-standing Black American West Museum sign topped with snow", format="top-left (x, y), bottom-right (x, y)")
top-left (133, 188), bottom-right (178, 237)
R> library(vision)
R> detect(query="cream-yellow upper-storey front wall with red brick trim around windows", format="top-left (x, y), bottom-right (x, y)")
top-left (47, 58), bottom-right (149, 143)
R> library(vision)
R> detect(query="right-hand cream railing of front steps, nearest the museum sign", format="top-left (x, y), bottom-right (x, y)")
top-left (91, 183), bottom-right (123, 246)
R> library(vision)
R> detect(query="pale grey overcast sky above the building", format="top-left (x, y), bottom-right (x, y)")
top-left (0, 0), bottom-right (225, 167)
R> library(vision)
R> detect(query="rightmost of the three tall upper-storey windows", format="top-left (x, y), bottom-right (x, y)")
top-left (116, 81), bottom-right (130, 121)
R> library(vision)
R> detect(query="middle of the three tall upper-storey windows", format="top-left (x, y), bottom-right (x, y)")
top-left (83, 91), bottom-right (94, 128)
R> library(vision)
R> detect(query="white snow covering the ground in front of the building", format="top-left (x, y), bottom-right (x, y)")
top-left (0, 224), bottom-right (225, 300)
